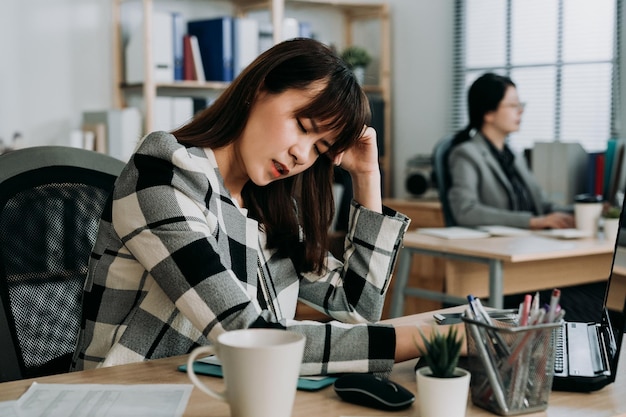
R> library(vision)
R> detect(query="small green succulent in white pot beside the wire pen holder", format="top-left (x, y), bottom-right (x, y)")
top-left (416, 326), bottom-right (470, 417)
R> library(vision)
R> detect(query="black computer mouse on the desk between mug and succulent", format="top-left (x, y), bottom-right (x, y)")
top-left (334, 374), bottom-right (415, 411)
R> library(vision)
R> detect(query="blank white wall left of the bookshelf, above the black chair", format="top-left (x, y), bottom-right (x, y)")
top-left (0, 0), bottom-right (112, 146)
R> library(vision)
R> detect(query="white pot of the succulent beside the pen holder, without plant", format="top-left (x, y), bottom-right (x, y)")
top-left (415, 366), bottom-right (470, 417)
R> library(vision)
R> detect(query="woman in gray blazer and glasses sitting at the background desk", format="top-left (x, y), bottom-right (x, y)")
top-left (448, 73), bottom-right (574, 229)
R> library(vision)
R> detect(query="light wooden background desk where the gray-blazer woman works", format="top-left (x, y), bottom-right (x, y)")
top-left (390, 232), bottom-right (614, 317)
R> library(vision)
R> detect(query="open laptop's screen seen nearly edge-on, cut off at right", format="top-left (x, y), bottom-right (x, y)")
top-left (602, 202), bottom-right (626, 381)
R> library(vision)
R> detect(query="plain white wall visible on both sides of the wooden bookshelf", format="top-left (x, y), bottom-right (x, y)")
top-left (0, 0), bottom-right (464, 196)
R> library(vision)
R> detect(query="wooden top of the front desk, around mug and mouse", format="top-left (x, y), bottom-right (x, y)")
top-left (0, 307), bottom-right (626, 417)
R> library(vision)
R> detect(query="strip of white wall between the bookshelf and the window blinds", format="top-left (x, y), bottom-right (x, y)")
top-left (390, 0), bottom-right (454, 197)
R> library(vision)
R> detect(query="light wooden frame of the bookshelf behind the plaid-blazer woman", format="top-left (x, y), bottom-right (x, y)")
top-left (112, 0), bottom-right (393, 196)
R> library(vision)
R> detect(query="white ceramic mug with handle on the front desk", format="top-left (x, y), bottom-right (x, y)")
top-left (187, 329), bottom-right (305, 417)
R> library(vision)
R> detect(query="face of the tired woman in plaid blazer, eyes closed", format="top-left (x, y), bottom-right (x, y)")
top-left (238, 84), bottom-right (334, 186)
